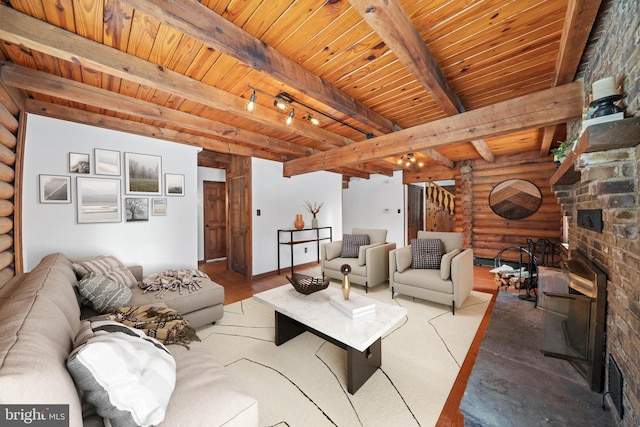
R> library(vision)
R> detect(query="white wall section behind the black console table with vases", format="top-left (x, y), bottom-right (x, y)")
top-left (252, 158), bottom-right (342, 275)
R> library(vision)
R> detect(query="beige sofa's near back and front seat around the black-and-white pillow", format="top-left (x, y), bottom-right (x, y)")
top-left (0, 254), bottom-right (258, 427)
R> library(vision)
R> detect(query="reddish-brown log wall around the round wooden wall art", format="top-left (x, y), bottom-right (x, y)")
top-left (471, 152), bottom-right (562, 262)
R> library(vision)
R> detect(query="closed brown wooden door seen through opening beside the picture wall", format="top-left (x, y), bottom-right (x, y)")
top-left (203, 181), bottom-right (227, 260)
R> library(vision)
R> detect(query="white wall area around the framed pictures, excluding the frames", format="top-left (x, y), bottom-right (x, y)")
top-left (22, 114), bottom-right (199, 273)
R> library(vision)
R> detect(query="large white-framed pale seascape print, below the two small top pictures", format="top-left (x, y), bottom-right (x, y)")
top-left (76, 177), bottom-right (122, 224)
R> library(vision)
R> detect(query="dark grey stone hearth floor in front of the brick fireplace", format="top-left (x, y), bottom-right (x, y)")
top-left (460, 290), bottom-right (617, 427)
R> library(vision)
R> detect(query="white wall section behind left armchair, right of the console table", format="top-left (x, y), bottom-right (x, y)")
top-left (336, 171), bottom-right (406, 247)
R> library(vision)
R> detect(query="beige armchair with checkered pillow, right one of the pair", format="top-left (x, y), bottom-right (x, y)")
top-left (389, 231), bottom-right (473, 314)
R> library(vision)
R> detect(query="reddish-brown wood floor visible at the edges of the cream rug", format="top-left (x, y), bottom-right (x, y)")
top-left (198, 260), bottom-right (497, 427)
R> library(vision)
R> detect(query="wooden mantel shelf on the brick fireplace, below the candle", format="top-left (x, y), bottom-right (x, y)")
top-left (550, 117), bottom-right (640, 188)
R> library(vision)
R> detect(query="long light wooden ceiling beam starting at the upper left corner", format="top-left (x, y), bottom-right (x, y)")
top-left (0, 6), bottom-right (353, 148)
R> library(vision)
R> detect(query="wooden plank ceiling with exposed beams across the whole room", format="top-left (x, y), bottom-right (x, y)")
top-left (0, 0), bottom-right (600, 180)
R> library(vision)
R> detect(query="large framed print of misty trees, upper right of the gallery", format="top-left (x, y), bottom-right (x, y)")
top-left (124, 153), bottom-right (162, 196)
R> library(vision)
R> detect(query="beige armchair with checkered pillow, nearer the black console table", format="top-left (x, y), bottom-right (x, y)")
top-left (320, 228), bottom-right (396, 292)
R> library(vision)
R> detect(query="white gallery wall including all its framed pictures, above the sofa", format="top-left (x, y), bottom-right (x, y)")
top-left (22, 114), bottom-right (199, 273)
